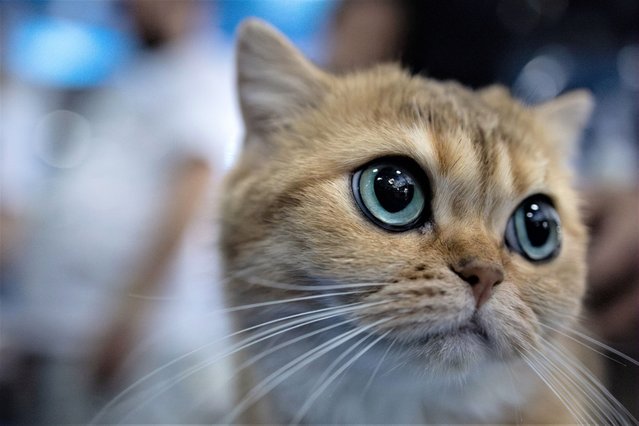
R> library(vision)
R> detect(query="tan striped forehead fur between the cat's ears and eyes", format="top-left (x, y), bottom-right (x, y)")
top-left (313, 69), bottom-right (551, 197)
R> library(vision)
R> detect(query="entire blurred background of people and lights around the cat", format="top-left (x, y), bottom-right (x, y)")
top-left (0, 0), bottom-right (639, 424)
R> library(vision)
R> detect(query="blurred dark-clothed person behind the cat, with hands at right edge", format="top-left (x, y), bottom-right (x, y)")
top-left (330, 0), bottom-right (639, 417)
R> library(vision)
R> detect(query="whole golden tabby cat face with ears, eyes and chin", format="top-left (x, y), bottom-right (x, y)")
top-left (222, 22), bottom-right (591, 372)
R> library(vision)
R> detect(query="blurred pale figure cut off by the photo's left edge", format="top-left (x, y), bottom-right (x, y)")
top-left (0, 27), bottom-right (75, 424)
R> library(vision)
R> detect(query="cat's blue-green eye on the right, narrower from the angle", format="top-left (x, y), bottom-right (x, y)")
top-left (506, 195), bottom-right (561, 262)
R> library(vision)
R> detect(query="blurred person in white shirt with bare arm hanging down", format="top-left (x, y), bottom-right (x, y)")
top-left (5, 0), bottom-right (239, 423)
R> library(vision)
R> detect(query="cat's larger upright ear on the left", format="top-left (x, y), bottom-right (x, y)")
top-left (237, 18), bottom-right (326, 132)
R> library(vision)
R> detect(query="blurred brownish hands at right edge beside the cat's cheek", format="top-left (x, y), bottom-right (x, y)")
top-left (585, 184), bottom-right (639, 417)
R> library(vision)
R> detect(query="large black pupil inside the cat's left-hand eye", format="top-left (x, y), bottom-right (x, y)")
top-left (374, 167), bottom-right (415, 213)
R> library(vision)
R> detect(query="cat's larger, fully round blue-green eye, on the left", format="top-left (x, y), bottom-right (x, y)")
top-left (352, 157), bottom-right (430, 231)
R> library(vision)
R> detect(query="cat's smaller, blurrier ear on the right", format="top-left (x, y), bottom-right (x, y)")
top-left (534, 90), bottom-right (595, 151)
